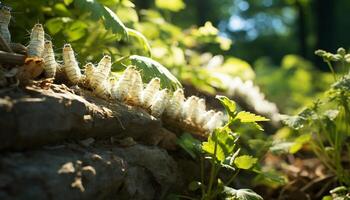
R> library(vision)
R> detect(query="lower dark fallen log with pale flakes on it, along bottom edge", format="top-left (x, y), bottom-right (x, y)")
top-left (0, 143), bottom-right (182, 200)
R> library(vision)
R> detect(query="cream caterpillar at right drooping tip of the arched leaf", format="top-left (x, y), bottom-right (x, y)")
top-left (165, 89), bottom-right (185, 119)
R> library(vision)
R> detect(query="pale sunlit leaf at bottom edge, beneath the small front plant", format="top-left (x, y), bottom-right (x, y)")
top-left (224, 186), bottom-right (264, 200)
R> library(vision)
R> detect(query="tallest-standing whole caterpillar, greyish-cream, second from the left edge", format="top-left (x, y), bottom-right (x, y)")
top-left (28, 24), bottom-right (45, 57)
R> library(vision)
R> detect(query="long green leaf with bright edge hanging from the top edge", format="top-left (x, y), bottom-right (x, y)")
top-left (74, 0), bottom-right (128, 40)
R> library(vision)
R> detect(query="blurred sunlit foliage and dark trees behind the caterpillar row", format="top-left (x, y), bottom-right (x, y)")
top-left (3, 0), bottom-right (350, 117)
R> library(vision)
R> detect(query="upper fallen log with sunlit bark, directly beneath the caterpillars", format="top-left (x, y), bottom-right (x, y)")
top-left (0, 81), bottom-right (176, 150)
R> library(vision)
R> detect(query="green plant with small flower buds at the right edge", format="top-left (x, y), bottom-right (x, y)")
top-left (284, 48), bottom-right (350, 187)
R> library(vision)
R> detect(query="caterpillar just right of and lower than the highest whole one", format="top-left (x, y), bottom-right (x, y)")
top-left (43, 41), bottom-right (58, 78)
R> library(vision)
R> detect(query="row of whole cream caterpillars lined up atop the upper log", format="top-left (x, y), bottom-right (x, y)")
top-left (28, 24), bottom-right (225, 134)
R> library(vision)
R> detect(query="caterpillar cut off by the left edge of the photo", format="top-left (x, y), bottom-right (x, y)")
top-left (0, 5), bottom-right (11, 44)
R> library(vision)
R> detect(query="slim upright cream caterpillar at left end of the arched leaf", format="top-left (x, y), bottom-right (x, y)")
top-left (128, 70), bottom-right (143, 105)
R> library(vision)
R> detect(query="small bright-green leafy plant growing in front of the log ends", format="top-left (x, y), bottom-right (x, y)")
top-left (179, 96), bottom-right (268, 200)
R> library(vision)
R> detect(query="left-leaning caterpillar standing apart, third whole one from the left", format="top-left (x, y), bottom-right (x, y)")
top-left (63, 44), bottom-right (82, 84)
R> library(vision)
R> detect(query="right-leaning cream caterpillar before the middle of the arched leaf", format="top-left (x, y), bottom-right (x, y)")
top-left (141, 78), bottom-right (160, 109)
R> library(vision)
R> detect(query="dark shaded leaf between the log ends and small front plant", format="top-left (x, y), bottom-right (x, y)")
top-left (176, 133), bottom-right (201, 158)
